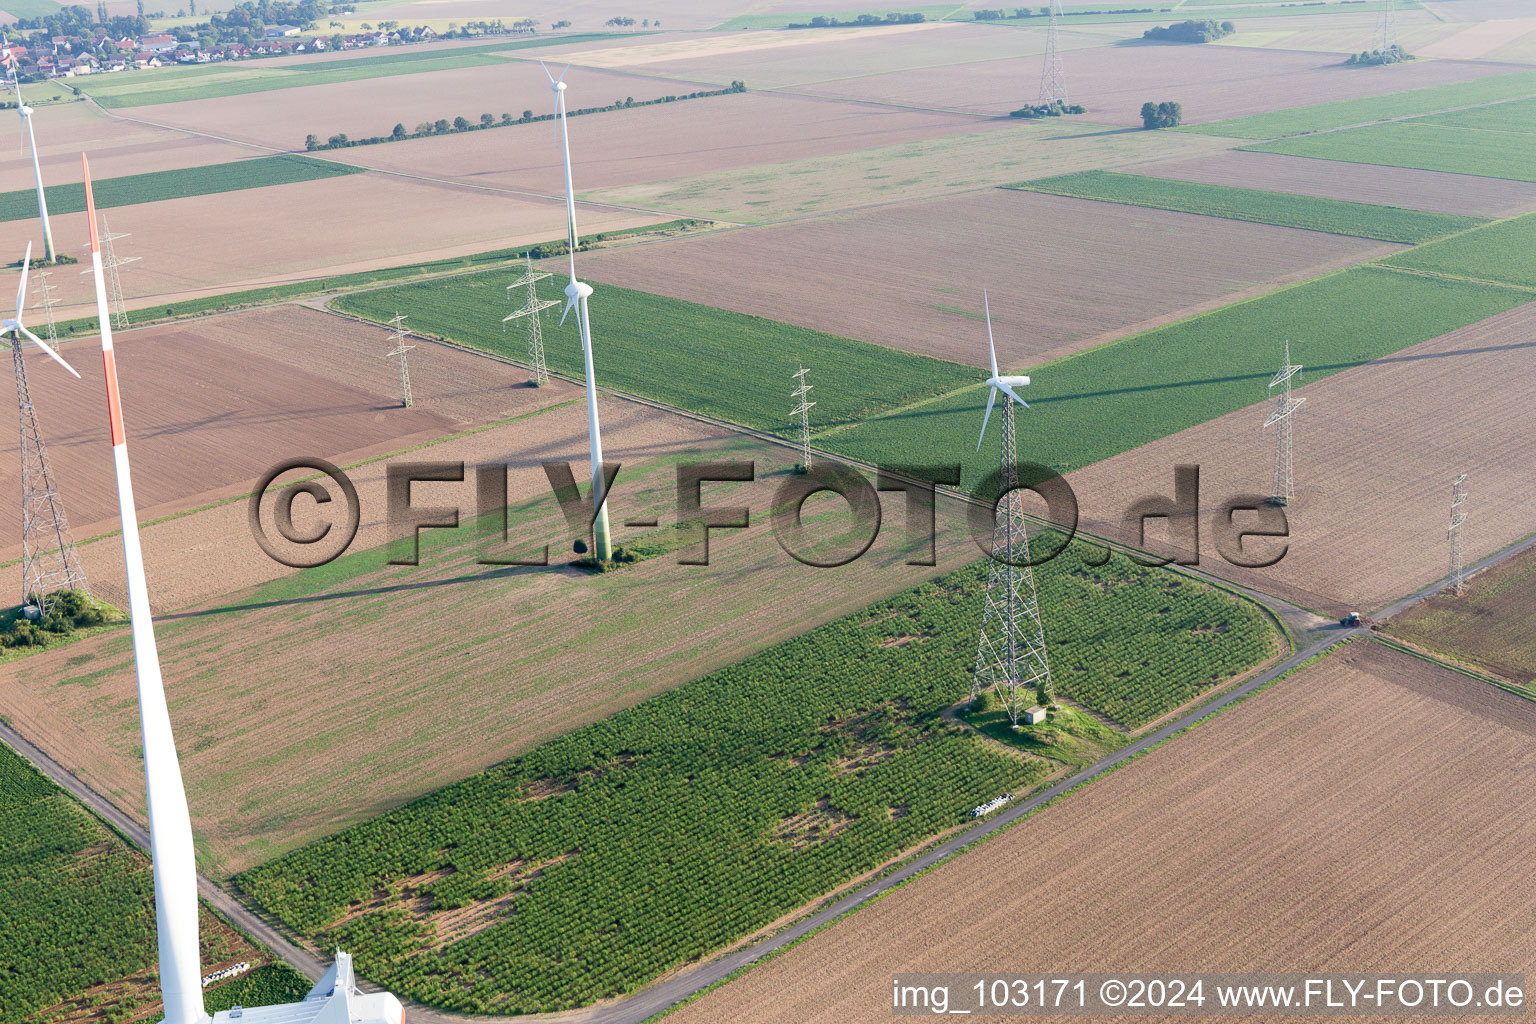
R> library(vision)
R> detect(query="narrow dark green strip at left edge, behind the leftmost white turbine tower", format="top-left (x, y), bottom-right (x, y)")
top-left (0, 155), bottom-right (362, 221)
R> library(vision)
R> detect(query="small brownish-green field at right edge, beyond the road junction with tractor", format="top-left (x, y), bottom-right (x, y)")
top-left (1387, 549), bottom-right (1536, 686)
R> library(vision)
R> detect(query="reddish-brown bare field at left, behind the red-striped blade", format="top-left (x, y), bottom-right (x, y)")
top-left (0, 306), bottom-right (579, 609)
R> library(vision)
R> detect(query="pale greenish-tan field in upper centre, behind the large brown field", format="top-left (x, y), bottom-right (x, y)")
top-left (587, 114), bottom-right (1232, 223)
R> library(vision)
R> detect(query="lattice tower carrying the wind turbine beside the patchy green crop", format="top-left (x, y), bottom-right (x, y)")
top-left (971, 395), bottom-right (1054, 725)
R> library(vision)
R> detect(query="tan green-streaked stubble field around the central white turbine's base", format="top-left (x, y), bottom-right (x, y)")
top-left (0, 411), bottom-right (975, 874)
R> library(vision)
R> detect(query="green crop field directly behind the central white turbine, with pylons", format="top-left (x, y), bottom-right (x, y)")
top-left (333, 273), bottom-right (975, 436)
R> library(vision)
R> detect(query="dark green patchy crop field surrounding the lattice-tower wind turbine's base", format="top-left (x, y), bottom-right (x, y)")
top-left (237, 550), bottom-right (1273, 1013)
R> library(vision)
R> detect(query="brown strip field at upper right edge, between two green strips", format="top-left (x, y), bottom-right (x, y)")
top-left (1123, 149), bottom-right (1536, 218)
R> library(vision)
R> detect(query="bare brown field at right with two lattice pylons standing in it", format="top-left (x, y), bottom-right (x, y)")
top-left (1069, 296), bottom-right (1536, 616)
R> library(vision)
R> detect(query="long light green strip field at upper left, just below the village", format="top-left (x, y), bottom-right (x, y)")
top-left (80, 32), bottom-right (607, 108)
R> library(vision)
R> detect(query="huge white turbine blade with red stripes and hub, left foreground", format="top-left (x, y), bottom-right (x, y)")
top-left (81, 155), bottom-right (402, 1024)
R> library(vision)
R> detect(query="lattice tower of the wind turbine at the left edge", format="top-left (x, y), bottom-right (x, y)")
top-left (11, 338), bottom-right (91, 616)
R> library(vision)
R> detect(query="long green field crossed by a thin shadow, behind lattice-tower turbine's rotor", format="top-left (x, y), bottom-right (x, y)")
top-left (814, 267), bottom-right (1530, 487)
